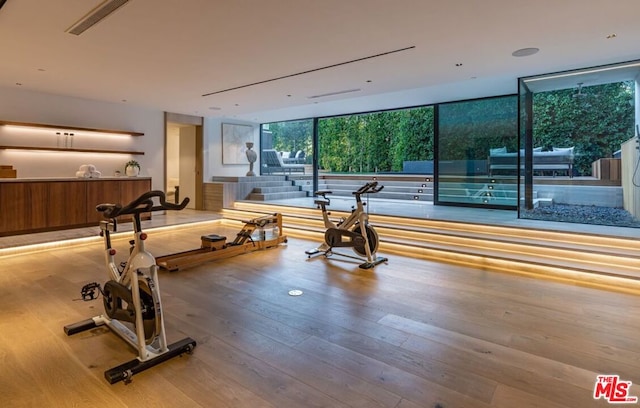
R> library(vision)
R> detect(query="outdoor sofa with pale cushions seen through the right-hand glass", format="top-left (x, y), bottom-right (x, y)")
top-left (488, 147), bottom-right (573, 177)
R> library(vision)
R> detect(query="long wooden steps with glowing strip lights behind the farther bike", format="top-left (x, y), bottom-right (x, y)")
top-left (223, 202), bottom-right (640, 293)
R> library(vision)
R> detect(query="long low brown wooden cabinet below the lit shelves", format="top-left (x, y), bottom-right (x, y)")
top-left (0, 178), bottom-right (151, 236)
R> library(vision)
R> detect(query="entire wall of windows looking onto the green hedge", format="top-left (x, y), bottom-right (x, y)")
top-left (261, 62), bottom-right (640, 227)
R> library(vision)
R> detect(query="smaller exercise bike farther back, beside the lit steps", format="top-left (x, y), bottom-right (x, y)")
top-left (305, 181), bottom-right (388, 269)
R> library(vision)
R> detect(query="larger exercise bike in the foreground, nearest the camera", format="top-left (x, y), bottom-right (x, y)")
top-left (64, 191), bottom-right (196, 384)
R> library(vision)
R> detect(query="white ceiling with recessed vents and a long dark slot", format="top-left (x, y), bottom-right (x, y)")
top-left (0, 0), bottom-right (640, 122)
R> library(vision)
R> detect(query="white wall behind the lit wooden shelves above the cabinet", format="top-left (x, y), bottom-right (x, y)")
top-left (0, 88), bottom-right (165, 190)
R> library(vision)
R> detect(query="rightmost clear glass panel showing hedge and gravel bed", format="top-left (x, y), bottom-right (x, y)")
top-left (519, 59), bottom-right (640, 227)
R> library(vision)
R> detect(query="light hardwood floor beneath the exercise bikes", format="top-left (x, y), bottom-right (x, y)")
top-left (0, 223), bottom-right (640, 408)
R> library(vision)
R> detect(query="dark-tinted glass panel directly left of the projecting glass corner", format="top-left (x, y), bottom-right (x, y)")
top-left (436, 96), bottom-right (519, 208)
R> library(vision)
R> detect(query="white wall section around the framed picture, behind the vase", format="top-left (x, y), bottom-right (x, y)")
top-left (202, 118), bottom-right (260, 178)
